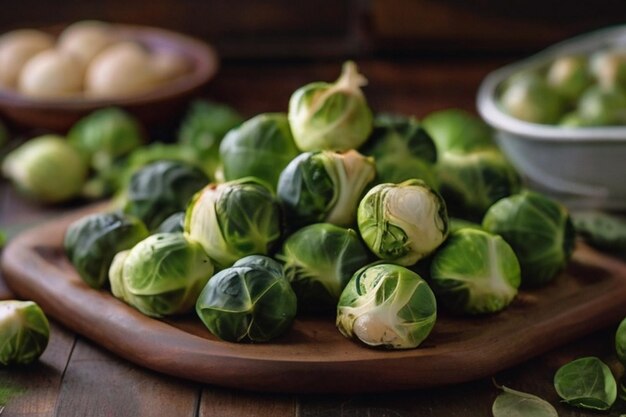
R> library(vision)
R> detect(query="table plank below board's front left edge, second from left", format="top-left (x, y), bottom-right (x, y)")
top-left (56, 338), bottom-right (200, 417)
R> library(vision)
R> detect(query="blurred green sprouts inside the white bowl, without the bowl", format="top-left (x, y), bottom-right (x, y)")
top-left (499, 47), bottom-right (626, 127)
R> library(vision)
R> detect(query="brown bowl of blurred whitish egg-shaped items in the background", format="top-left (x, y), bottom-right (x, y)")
top-left (0, 20), bottom-right (218, 131)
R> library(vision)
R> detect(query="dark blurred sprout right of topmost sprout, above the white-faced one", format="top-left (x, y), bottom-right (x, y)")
top-left (361, 115), bottom-right (437, 188)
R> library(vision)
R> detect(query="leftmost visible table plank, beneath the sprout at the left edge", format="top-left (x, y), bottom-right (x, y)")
top-left (0, 323), bottom-right (76, 417)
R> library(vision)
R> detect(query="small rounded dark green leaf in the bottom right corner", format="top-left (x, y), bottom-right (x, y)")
top-left (554, 356), bottom-right (617, 411)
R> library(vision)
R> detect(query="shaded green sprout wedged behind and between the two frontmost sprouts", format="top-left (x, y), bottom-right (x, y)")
top-left (277, 223), bottom-right (370, 312)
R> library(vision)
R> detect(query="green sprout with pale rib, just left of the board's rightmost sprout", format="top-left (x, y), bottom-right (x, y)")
top-left (429, 229), bottom-right (521, 314)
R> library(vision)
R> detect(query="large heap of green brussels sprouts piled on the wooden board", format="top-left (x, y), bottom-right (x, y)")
top-left (58, 62), bottom-right (574, 348)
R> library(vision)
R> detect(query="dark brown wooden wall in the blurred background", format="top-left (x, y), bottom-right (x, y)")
top-left (0, 0), bottom-right (626, 58)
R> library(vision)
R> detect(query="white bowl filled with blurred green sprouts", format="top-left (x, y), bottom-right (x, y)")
top-left (477, 26), bottom-right (626, 210)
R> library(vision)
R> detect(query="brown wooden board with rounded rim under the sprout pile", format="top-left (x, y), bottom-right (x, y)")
top-left (2, 206), bottom-right (626, 392)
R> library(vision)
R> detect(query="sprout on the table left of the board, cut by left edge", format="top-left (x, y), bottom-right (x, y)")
top-left (0, 300), bottom-right (50, 365)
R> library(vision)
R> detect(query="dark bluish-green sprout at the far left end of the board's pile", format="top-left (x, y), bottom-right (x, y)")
top-left (63, 213), bottom-right (148, 288)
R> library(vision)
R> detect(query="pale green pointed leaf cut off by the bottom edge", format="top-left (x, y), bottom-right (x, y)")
top-left (491, 386), bottom-right (559, 417)
